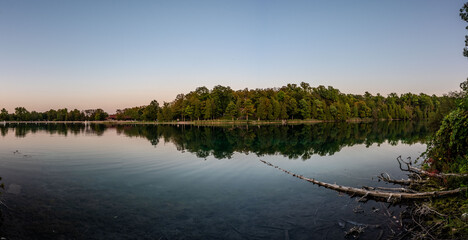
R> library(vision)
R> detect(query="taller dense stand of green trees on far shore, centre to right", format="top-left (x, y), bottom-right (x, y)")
top-left (151, 82), bottom-right (454, 121)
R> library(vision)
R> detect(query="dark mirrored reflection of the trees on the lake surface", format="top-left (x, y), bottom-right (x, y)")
top-left (0, 121), bottom-right (433, 160)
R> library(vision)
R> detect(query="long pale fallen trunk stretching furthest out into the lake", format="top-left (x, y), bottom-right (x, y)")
top-left (260, 160), bottom-right (467, 202)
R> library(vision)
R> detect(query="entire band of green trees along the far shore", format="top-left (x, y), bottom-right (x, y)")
top-left (0, 82), bottom-right (459, 122)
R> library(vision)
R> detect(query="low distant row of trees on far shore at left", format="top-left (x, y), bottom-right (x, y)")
top-left (0, 107), bottom-right (109, 121)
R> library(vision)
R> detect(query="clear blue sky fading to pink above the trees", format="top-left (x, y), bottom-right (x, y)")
top-left (0, 0), bottom-right (468, 113)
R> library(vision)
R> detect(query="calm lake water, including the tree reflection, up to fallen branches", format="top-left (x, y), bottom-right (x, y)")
top-left (0, 122), bottom-right (431, 239)
